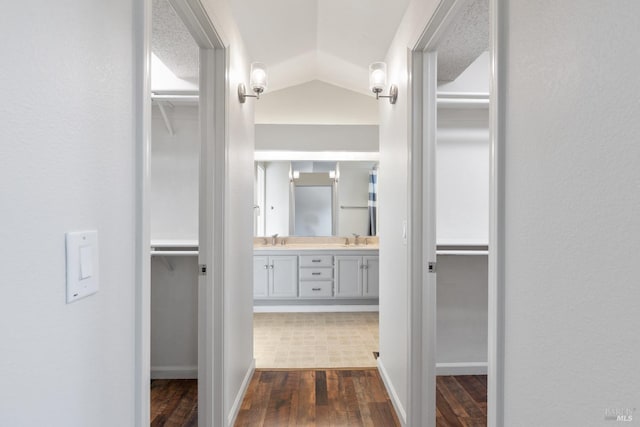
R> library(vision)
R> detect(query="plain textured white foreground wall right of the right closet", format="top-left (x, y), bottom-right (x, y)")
top-left (503, 0), bottom-right (640, 426)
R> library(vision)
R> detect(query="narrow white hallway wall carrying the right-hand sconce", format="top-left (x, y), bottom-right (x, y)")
top-left (378, 0), bottom-right (438, 422)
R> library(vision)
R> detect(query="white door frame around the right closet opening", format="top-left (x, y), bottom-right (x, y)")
top-left (408, 0), bottom-right (506, 427)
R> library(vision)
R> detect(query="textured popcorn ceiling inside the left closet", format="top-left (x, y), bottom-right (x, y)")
top-left (151, 0), bottom-right (199, 84)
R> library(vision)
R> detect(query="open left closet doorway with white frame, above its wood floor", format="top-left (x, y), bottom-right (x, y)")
top-left (136, 0), bottom-right (226, 425)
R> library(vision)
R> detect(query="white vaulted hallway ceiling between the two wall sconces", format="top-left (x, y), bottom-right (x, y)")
top-left (230, 0), bottom-right (409, 94)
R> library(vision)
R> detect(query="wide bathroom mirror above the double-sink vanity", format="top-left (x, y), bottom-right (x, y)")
top-left (254, 160), bottom-right (377, 236)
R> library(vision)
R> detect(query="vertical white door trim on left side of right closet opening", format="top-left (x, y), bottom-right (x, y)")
top-left (407, 50), bottom-right (437, 426)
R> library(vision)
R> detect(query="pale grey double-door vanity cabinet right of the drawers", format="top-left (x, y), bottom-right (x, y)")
top-left (335, 255), bottom-right (379, 298)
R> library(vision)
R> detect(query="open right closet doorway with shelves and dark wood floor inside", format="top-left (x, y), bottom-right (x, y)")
top-left (410, 0), bottom-right (495, 425)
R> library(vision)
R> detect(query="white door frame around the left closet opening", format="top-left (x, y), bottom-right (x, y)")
top-left (134, 0), bottom-right (229, 427)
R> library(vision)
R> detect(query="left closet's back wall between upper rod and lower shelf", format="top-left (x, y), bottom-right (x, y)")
top-left (149, 106), bottom-right (200, 241)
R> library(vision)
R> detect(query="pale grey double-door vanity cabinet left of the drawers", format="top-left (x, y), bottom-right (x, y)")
top-left (253, 255), bottom-right (298, 299)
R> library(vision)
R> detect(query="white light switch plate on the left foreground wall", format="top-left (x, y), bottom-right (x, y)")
top-left (66, 230), bottom-right (99, 304)
